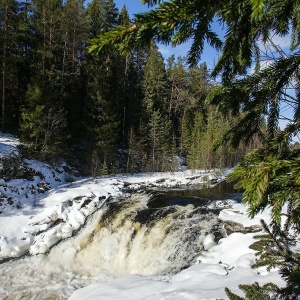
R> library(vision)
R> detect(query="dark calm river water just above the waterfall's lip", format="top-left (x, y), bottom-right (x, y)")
top-left (148, 181), bottom-right (242, 208)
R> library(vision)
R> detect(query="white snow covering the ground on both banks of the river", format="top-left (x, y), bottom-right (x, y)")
top-left (0, 134), bottom-right (284, 300)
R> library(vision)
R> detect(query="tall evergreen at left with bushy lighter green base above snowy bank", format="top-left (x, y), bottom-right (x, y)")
top-left (20, 0), bottom-right (69, 161)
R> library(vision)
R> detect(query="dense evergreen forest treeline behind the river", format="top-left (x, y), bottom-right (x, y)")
top-left (0, 0), bottom-right (259, 176)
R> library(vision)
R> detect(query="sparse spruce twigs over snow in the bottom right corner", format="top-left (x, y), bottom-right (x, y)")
top-left (225, 214), bottom-right (300, 300)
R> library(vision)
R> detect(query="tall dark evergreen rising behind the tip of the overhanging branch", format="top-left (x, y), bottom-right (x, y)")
top-left (85, 0), bottom-right (120, 175)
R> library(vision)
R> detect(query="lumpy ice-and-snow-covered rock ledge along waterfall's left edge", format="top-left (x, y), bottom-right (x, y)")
top-left (0, 195), bottom-right (111, 260)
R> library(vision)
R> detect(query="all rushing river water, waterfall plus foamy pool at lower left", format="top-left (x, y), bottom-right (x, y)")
top-left (0, 182), bottom-right (237, 299)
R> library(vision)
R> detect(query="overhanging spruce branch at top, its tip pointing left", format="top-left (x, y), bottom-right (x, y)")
top-left (90, 0), bottom-right (222, 65)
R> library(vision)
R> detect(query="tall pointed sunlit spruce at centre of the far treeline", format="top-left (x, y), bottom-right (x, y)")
top-left (140, 43), bottom-right (171, 171)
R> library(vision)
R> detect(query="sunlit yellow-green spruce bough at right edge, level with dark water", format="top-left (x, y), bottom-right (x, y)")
top-left (228, 147), bottom-right (300, 226)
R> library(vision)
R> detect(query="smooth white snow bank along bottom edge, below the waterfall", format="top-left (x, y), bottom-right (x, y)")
top-left (69, 264), bottom-right (283, 300)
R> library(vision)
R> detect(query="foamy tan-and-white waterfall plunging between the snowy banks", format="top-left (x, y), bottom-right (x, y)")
top-left (48, 195), bottom-right (225, 277)
